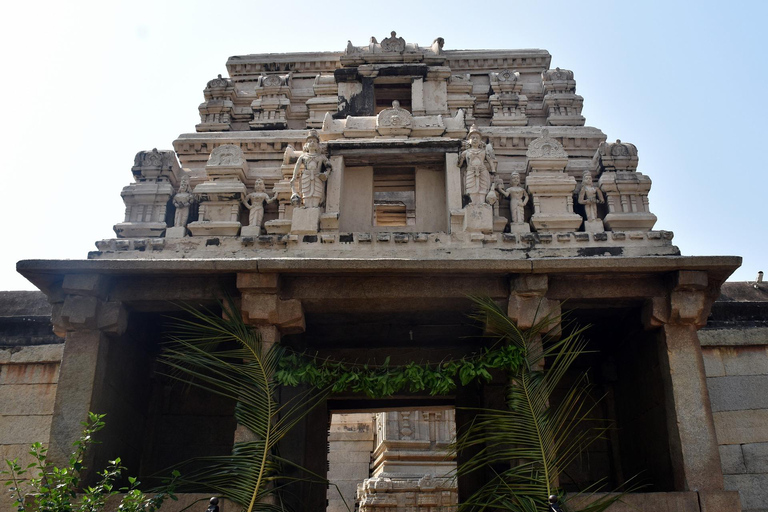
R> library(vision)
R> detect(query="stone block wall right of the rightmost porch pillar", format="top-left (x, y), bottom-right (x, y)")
top-left (699, 283), bottom-right (768, 512)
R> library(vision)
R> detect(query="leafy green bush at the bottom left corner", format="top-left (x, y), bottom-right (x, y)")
top-left (0, 413), bottom-right (179, 512)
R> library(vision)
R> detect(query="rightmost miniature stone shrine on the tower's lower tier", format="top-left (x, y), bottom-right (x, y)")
top-left (593, 140), bottom-right (656, 231)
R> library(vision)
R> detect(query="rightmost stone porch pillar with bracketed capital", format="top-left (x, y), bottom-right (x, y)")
top-left (643, 270), bottom-right (738, 500)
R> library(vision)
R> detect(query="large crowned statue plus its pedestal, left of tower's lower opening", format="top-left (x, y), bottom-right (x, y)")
top-left (290, 129), bottom-right (333, 234)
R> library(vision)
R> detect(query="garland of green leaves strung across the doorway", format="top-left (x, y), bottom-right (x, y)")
top-left (275, 344), bottom-right (523, 398)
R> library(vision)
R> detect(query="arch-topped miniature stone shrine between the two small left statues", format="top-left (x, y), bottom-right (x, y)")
top-left (187, 144), bottom-right (248, 236)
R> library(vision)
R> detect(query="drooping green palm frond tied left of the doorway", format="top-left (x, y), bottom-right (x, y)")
top-left (161, 301), bottom-right (328, 512)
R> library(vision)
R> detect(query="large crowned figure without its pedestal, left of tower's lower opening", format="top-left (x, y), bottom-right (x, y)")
top-left (291, 130), bottom-right (333, 208)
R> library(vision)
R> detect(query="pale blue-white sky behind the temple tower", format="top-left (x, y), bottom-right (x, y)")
top-left (0, 0), bottom-right (768, 290)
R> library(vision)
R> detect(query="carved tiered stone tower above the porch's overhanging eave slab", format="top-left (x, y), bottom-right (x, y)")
top-left (90, 32), bottom-right (679, 259)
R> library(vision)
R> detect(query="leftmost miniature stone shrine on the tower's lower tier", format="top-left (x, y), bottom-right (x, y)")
top-left (114, 149), bottom-right (180, 238)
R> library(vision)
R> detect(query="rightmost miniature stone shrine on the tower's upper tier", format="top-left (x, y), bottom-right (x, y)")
top-left (541, 68), bottom-right (586, 126)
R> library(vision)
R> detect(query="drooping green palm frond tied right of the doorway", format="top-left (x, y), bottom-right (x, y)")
top-left (455, 299), bottom-right (621, 512)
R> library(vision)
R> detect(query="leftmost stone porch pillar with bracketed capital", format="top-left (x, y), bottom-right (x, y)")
top-left (48, 274), bottom-right (127, 469)
